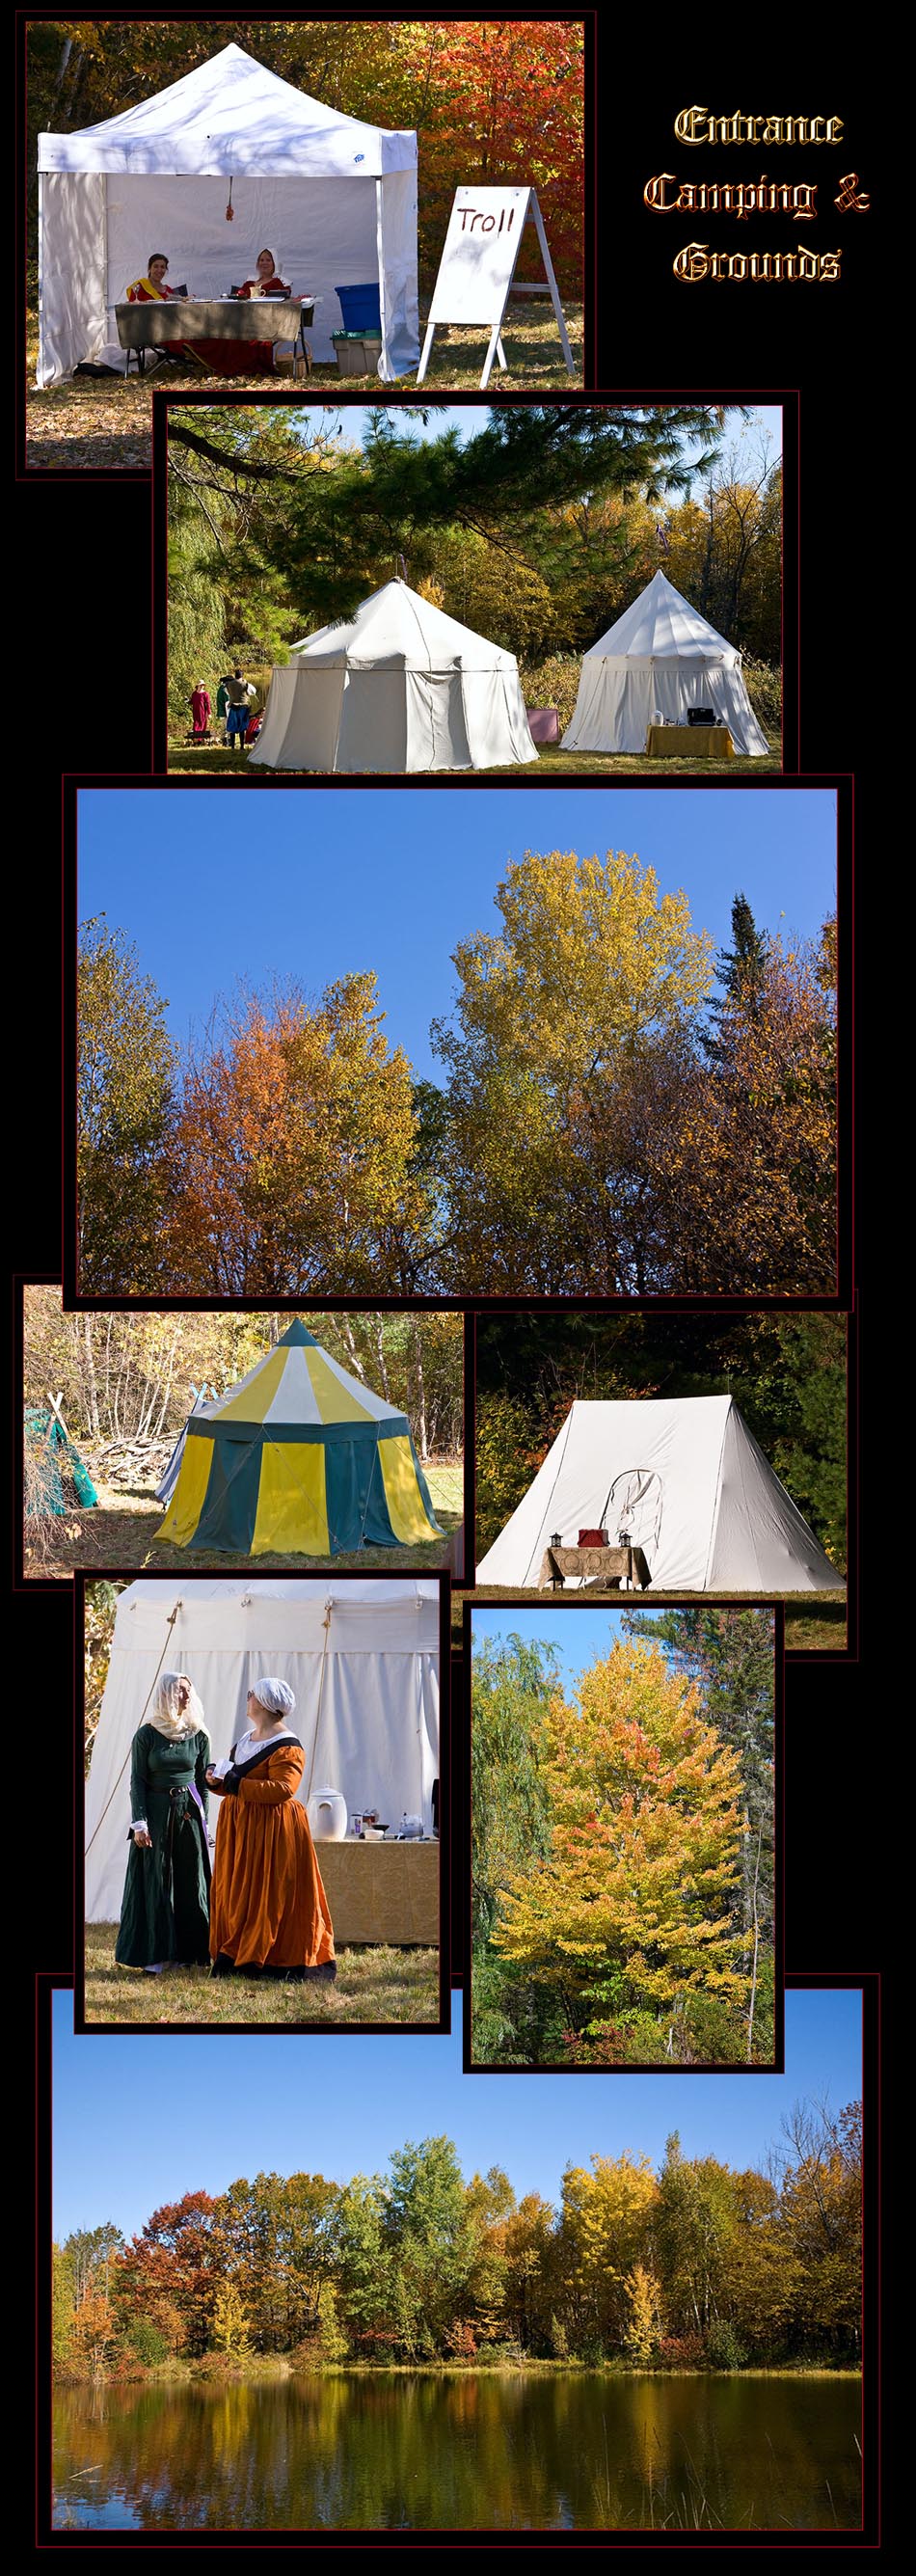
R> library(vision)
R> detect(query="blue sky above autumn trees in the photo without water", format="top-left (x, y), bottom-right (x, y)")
top-left (77, 783), bottom-right (836, 1076)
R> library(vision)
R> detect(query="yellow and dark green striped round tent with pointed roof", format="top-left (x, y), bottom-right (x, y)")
top-left (157, 1321), bottom-right (443, 1556)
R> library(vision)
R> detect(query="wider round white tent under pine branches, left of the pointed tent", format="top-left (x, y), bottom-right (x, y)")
top-left (250, 583), bottom-right (538, 771)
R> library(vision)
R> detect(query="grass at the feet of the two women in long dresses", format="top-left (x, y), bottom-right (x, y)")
top-left (85, 1924), bottom-right (440, 2030)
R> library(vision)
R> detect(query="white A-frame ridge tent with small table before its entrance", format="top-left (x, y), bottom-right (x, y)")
top-left (476, 1396), bottom-right (842, 1594)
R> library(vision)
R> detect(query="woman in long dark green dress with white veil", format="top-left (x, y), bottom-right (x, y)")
top-left (116, 1671), bottom-right (211, 1973)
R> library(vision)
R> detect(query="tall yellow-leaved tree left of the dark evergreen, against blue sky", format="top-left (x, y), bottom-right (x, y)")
top-left (432, 850), bottom-right (711, 1290)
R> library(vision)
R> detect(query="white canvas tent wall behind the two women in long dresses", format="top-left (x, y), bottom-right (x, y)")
top-left (85, 1577), bottom-right (440, 1922)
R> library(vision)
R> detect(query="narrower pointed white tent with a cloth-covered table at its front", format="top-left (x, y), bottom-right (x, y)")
top-left (563, 572), bottom-right (769, 760)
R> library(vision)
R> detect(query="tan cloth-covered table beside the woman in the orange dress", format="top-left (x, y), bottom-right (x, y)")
top-left (314, 1836), bottom-right (440, 1950)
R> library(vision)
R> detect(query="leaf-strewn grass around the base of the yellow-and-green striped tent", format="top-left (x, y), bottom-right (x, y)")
top-left (26, 1452), bottom-right (463, 1576)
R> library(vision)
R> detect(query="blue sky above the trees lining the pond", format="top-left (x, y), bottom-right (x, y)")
top-left (54, 1992), bottom-right (862, 2238)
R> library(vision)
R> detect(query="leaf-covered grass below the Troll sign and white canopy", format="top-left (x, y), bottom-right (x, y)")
top-left (26, 288), bottom-right (584, 474)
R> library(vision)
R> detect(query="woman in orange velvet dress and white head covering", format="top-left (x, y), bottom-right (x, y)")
top-left (205, 1677), bottom-right (337, 1984)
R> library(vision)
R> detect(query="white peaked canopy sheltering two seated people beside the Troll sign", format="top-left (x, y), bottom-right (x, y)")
top-left (39, 43), bottom-right (419, 384)
